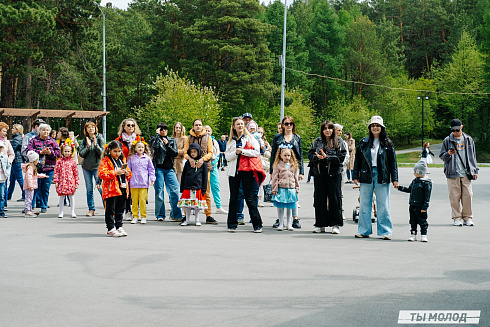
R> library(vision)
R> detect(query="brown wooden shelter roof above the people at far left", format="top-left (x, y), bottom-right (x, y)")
top-left (0, 108), bottom-right (109, 135)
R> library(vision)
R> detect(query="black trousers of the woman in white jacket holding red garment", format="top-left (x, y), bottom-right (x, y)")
top-left (228, 171), bottom-right (262, 228)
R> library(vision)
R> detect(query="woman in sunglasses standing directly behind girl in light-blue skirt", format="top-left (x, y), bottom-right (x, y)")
top-left (270, 116), bottom-right (304, 228)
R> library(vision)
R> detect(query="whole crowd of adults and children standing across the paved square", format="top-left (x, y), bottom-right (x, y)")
top-left (0, 113), bottom-right (478, 242)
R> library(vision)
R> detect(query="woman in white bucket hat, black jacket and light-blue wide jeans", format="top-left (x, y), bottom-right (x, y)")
top-left (352, 116), bottom-right (398, 240)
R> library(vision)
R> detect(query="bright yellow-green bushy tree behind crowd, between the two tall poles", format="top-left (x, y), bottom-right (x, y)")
top-left (134, 70), bottom-right (220, 135)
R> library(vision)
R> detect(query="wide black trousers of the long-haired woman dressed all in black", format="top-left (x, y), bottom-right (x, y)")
top-left (313, 174), bottom-right (344, 227)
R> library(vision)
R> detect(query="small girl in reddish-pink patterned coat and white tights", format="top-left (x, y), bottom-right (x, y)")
top-left (53, 144), bottom-right (80, 218)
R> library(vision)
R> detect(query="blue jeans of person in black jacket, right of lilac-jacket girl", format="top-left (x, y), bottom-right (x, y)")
top-left (153, 167), bottom-right (182, 219)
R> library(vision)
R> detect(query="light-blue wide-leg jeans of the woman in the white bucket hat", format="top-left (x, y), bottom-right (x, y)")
top-left (357, 167), bottom-right (393, 236)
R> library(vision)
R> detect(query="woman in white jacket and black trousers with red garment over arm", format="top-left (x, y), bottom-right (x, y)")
top-left (225, 117), bottom-right (265, 233)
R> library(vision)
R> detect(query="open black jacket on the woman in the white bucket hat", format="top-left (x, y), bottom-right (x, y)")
top-left (352, 137), bottom-right (398, 184)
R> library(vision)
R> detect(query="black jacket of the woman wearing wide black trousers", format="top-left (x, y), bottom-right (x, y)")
top-left (308, 137), bottom-right (347, 176)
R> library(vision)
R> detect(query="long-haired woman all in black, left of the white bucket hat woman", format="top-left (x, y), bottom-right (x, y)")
top-left (308, 120), bottom-right (347, 234)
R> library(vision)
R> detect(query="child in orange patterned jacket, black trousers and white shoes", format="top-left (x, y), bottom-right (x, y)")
top-left (99, 141), bottom-right (132, 237)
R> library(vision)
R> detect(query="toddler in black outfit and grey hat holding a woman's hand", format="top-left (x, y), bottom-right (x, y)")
top-left (398, 160), bottom-right (432, 242)
